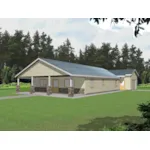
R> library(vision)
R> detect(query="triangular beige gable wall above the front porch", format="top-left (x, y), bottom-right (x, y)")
top-left (19, 61), bottom-right (64, 77)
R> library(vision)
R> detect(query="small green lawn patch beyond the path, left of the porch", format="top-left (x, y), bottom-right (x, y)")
top-left (0, 87), bottom-right (29, 97)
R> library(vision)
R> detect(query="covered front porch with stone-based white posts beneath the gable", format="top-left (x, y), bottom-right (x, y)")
top-left (16, 76), bottom-right (77, 97)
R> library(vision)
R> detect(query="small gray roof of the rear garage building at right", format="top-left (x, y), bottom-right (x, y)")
top-left (109, 69), bottom-right (135, 76)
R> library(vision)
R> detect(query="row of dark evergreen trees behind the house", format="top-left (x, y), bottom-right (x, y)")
top-left (0, 30), bottom-right (150, 83)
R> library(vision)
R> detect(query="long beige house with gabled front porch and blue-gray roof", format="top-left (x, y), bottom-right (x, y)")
top-left (15, 58), bottom-right (120, 96)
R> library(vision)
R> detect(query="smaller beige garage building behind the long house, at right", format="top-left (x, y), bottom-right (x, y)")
top-left (109, 69), bottom-right (139, 90)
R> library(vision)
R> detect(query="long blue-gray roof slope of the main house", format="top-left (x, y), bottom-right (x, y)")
top-left (40, 58), bottom-right (118, 78)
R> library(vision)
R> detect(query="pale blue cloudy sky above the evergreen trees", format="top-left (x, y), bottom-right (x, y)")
top-left (0, 18), bottom-right (150, 61)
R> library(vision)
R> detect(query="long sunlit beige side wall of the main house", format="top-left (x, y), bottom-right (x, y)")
top-left (85, 78), bottom-right (120, 94)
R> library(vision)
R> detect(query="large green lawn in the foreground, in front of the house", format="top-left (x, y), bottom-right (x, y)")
top-left (0, 91), bottom-right (150, 131)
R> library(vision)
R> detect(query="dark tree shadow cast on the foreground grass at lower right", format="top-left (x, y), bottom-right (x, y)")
top-left (77, 116), bottom-right (143, 131)
